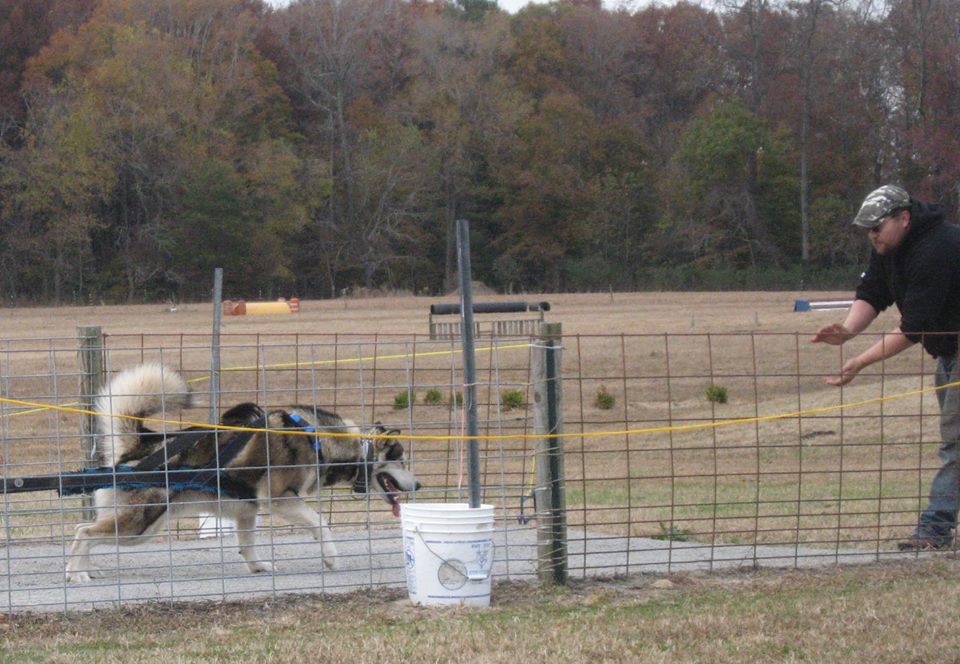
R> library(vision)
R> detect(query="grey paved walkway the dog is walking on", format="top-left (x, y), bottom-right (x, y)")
top-left (0, 525), bottom-right (928, 613)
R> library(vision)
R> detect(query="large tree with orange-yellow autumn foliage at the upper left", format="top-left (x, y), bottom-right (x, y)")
top-left (10, 0), bottom-right (305, 301)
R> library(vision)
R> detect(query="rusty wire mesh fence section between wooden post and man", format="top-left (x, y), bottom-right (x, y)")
top-left (565, 333), bottom-right (939, 569)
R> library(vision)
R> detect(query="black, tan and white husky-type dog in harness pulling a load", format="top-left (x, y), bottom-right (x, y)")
top-left (66, 364), bottom-right (420, 582)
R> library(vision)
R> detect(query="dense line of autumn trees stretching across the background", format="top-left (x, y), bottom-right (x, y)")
top-left (0, 0), bottom-right (960, 303)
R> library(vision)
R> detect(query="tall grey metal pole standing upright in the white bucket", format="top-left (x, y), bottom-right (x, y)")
top-left (457, 219), bottom-right (480, 508)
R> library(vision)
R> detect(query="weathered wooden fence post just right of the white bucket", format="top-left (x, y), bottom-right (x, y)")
top-left (531, 323), bottom-right (567, 584)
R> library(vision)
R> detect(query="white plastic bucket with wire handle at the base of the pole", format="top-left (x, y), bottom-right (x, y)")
top-left (400, 503), bottom-right (493, 606)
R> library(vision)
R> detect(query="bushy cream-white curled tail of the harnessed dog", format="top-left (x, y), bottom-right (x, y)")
top-left (94, 363), bottom-right (191, 466)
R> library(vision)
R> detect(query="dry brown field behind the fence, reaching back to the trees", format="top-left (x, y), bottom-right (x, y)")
top-left (0, 293), bottom-right (936, 546)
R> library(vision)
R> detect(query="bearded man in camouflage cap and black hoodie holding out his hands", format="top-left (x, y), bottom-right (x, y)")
top-left (811, 185), bottom-right (960, 551)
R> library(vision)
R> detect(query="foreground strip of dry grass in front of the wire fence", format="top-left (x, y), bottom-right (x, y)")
top-left (0, 558), bottom-right (960, 664)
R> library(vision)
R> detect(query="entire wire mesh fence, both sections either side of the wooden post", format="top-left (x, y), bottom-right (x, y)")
top-left (0, 332), bottom-right (940, 611)
